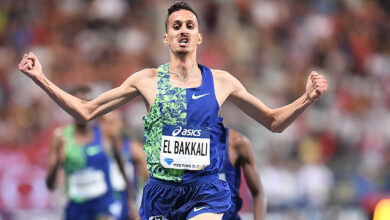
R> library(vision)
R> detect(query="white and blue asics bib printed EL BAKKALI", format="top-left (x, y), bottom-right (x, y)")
top-left (160, 125), bottom-right (211, 170)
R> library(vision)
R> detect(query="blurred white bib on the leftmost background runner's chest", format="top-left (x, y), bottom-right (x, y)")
top-left (69, 169), bottom-right (107, 200)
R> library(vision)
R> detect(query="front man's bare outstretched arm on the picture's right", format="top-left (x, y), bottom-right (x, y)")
top-left (216, 71), bottom-right (328, 132)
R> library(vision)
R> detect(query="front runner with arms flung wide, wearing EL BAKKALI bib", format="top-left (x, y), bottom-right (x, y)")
top-left (19, 2), bottom-right (327, 220)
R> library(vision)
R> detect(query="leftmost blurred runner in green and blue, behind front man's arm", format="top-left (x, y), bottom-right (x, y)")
top-left (46, 87), bottom-right (128, 220)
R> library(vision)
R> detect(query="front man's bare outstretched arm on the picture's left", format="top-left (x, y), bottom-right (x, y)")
top-left (19, 53), bottom-right (145, 122)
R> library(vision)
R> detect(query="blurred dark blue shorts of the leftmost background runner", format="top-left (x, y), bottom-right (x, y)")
top-left (65, 195), bottom-right (115, 220)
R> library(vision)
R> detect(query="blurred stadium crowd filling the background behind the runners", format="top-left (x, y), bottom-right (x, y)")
top-left (0, 0), bottom-right (390, 220)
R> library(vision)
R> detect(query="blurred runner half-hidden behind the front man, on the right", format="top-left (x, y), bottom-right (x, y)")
top-left (219, 128), bottom-right (267, 220)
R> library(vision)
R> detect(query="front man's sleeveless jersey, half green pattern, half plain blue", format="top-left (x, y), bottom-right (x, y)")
top-left (143, 64), bottom-right (225, 182)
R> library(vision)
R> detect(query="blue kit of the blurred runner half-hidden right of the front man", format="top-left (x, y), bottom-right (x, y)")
top-left (219, 128), bottom-right (242, 219)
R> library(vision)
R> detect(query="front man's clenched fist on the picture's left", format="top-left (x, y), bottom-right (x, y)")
top-left (19, 52), bottom-right (43, 80)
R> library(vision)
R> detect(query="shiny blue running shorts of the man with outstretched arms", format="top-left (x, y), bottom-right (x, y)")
top-left (139, 175), bottom-right (231, 220)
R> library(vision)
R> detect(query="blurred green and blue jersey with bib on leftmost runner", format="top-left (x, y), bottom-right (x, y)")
top-left (64, 125), bottom-right (112, 203)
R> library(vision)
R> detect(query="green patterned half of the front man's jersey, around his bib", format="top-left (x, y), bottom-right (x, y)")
top-left (143, 64), bottom-right (187, 182)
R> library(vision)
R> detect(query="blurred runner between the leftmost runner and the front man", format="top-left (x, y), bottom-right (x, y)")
top-left (100, 111), bottom-right (149, 220)
